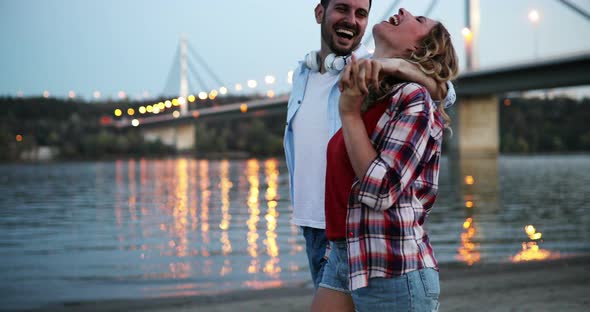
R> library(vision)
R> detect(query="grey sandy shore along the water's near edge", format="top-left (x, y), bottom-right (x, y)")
top-left (25, 256), bottom-right (590, 312)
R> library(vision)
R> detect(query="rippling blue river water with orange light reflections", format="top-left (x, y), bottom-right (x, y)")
top-left (0, 156), bottom-right (590, 308)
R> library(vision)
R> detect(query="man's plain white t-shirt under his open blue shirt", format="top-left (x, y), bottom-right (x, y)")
top-left (293, 72), bottom-right (338, 229)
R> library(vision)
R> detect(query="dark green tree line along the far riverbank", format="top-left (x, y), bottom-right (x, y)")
top-left (0, 97), bottom-right (590, 161)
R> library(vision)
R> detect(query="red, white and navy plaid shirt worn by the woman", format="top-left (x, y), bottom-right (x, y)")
top-left (346, 83), bottom-right (444, 290)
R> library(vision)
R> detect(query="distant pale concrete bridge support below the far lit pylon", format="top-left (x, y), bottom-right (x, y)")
top-left (142, 124), bottom-right (195, 151)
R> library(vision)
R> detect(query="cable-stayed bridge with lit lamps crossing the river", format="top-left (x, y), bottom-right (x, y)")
top-left (108, 0), bottom-right (590, 155)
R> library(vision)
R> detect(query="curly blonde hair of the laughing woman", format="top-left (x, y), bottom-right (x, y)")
top-left (363, 23), bottom-right (459, 128)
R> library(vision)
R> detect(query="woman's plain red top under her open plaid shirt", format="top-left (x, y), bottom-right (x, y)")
top-left (325, 98), bottom-right (390, 240)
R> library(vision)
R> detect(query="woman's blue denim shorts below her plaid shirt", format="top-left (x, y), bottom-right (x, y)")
top-left (320, 241), bottom-right (440, 312)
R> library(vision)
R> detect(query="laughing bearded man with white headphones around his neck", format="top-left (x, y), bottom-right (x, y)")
top-left (283, 0), bottom-right (454, 289)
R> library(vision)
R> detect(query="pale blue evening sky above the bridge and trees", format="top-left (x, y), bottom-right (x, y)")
top-left (0, 0), bottom-right (590, 99)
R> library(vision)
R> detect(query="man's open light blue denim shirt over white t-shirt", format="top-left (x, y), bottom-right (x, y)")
top-left (283, 45), bottom-right (456, 204)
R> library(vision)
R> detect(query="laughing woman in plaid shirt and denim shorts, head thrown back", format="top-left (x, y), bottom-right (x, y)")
top-left (312, 9), bottom-right (458, 311)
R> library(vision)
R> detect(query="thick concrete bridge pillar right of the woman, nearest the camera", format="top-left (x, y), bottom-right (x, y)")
top-left (456, 95), bottom-right (500, 158)
